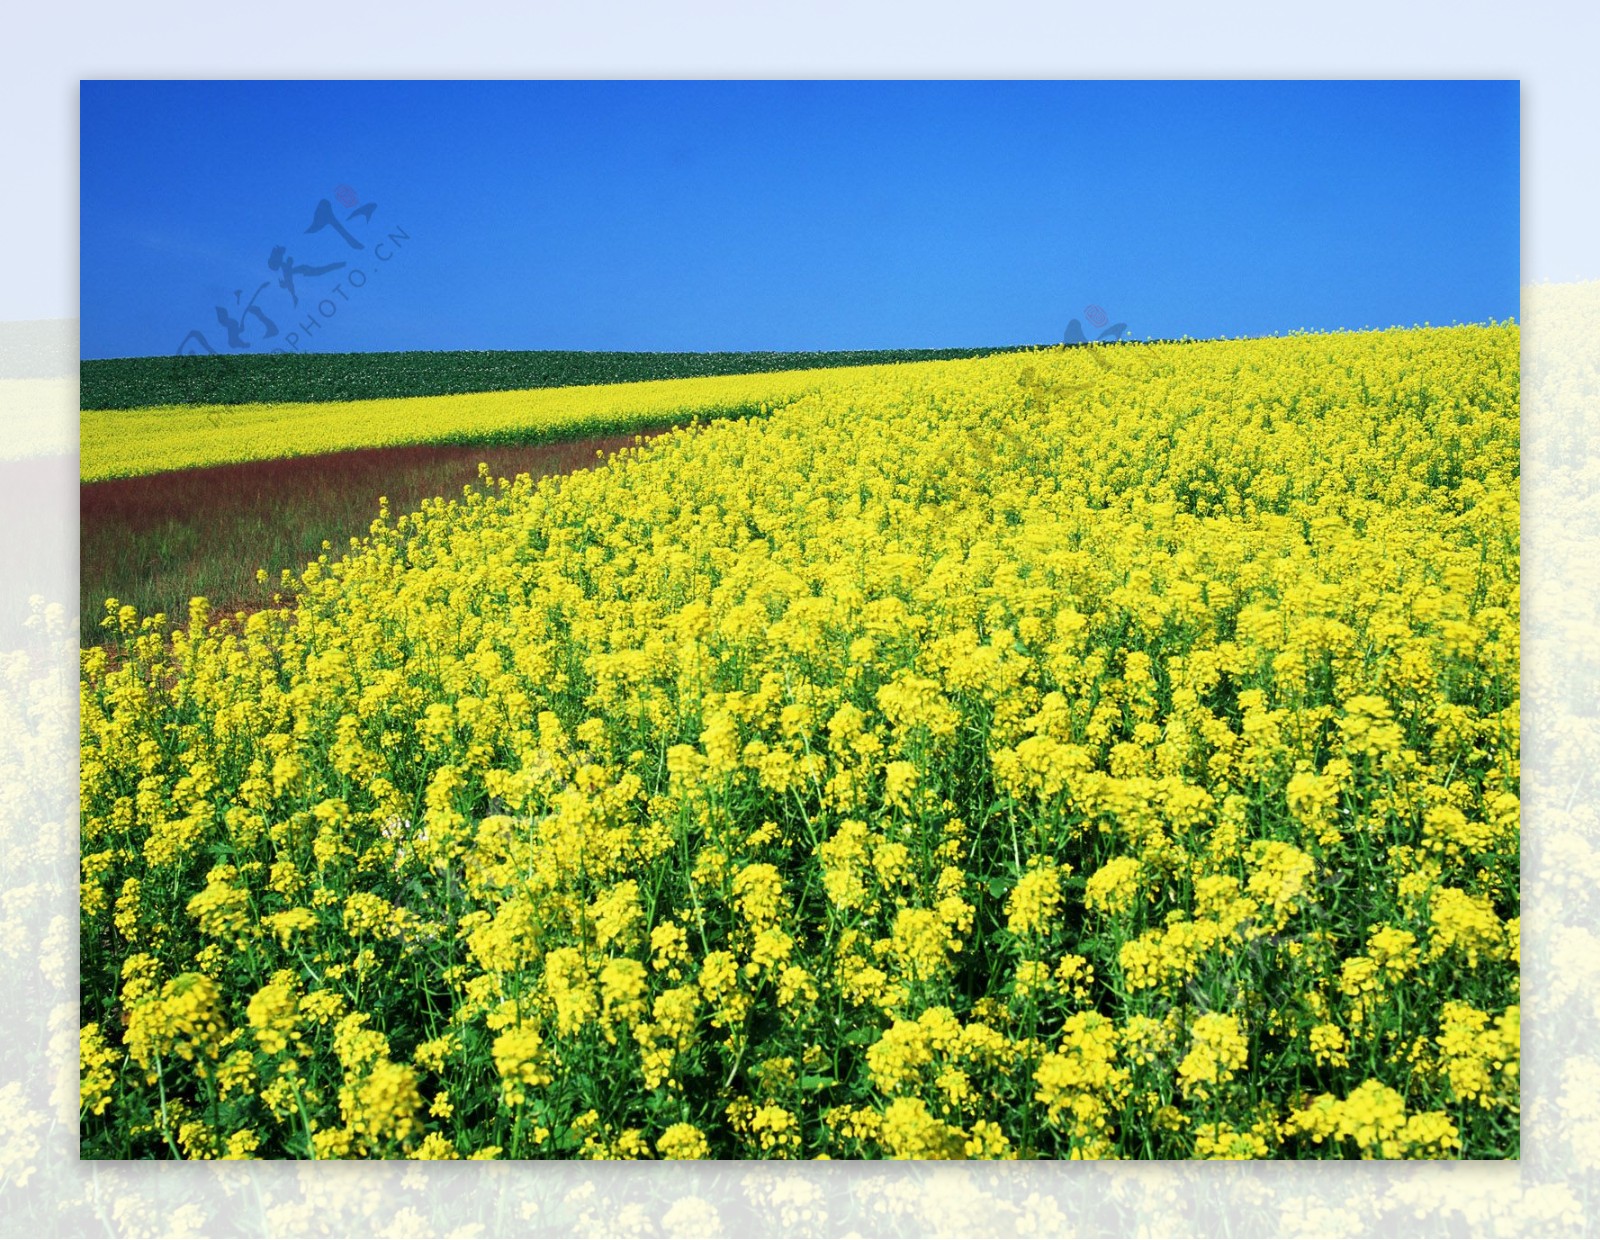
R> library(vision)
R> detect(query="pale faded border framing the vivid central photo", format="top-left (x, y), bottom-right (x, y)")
top-left (0, 0), bottom-right (1600, 1237)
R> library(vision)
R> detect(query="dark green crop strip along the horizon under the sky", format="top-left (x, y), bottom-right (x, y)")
top-left (78, 346), bottom-right (1035, 410)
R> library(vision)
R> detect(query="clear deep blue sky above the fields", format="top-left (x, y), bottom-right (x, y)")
top-left (80, 82), bottom-right (1520, 358)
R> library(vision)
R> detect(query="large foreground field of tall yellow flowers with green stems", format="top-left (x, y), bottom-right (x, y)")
top-left (80, 325), bottom-right (1520, 1158)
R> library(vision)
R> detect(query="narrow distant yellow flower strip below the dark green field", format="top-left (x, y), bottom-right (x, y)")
top-left (80, 366), bottom-right (928, 482)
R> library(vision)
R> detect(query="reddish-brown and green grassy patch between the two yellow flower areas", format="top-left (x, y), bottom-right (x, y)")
top-left (78, 432), bottom-right (651, 645)
